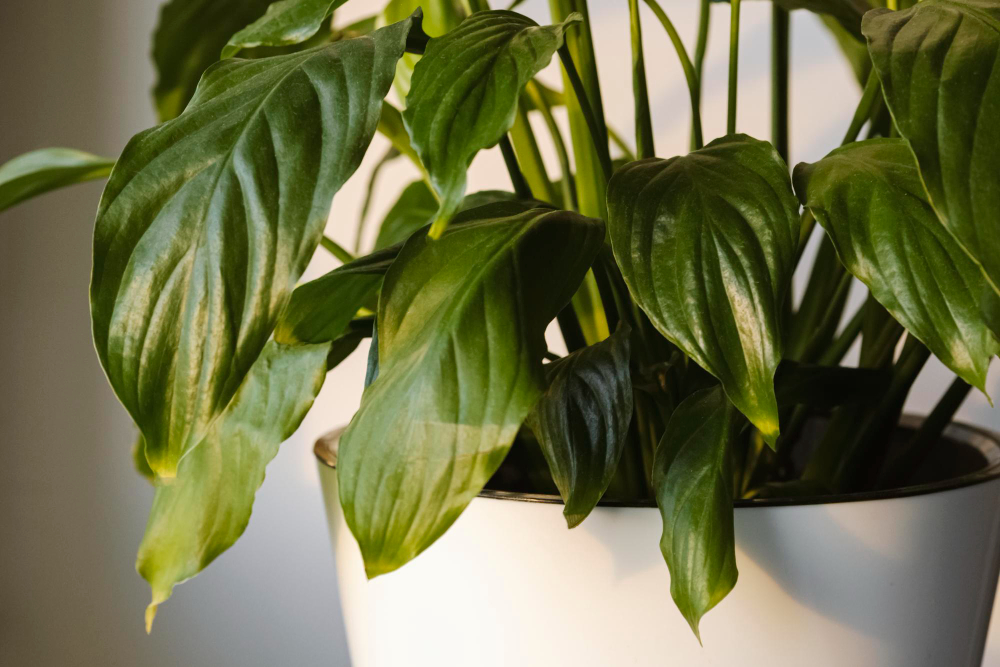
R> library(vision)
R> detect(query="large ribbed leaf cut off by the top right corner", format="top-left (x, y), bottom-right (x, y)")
top-left (863, 0), bottom-right (1000, 298)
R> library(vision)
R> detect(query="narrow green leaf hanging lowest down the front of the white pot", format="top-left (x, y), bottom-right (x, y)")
top-left (653, 385), bottom-right (741, 641)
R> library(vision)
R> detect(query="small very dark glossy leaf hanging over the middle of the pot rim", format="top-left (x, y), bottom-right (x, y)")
top-left (527, 322), bottom-right (632, 528)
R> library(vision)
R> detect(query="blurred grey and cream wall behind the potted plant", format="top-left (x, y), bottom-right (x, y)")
top-left (0, 0), bottom-right (1000, 667)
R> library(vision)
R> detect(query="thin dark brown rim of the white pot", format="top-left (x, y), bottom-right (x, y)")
top-left (313, 415), bottom-right (1000, 509)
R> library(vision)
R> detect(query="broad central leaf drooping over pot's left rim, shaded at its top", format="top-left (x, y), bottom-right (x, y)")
top-left (337, 203), bottom-right (604, 577)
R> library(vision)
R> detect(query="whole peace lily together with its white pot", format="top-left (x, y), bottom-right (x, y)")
top-left (0, 0), bottom-right (1000, 666)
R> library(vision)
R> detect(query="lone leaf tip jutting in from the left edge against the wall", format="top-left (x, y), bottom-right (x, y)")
top-left (0, 148), bottom-right (115, 211)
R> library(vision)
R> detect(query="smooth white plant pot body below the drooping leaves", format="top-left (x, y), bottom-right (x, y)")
top-left (317, 424), bottom-right (1000, 667)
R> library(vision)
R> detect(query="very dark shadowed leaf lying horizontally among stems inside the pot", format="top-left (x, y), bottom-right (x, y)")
top-left (774, 360), bottom-right (892, 410)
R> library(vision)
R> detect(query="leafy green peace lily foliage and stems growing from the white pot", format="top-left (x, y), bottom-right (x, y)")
top-left (0, 0), bottom-right (1000, 633)
